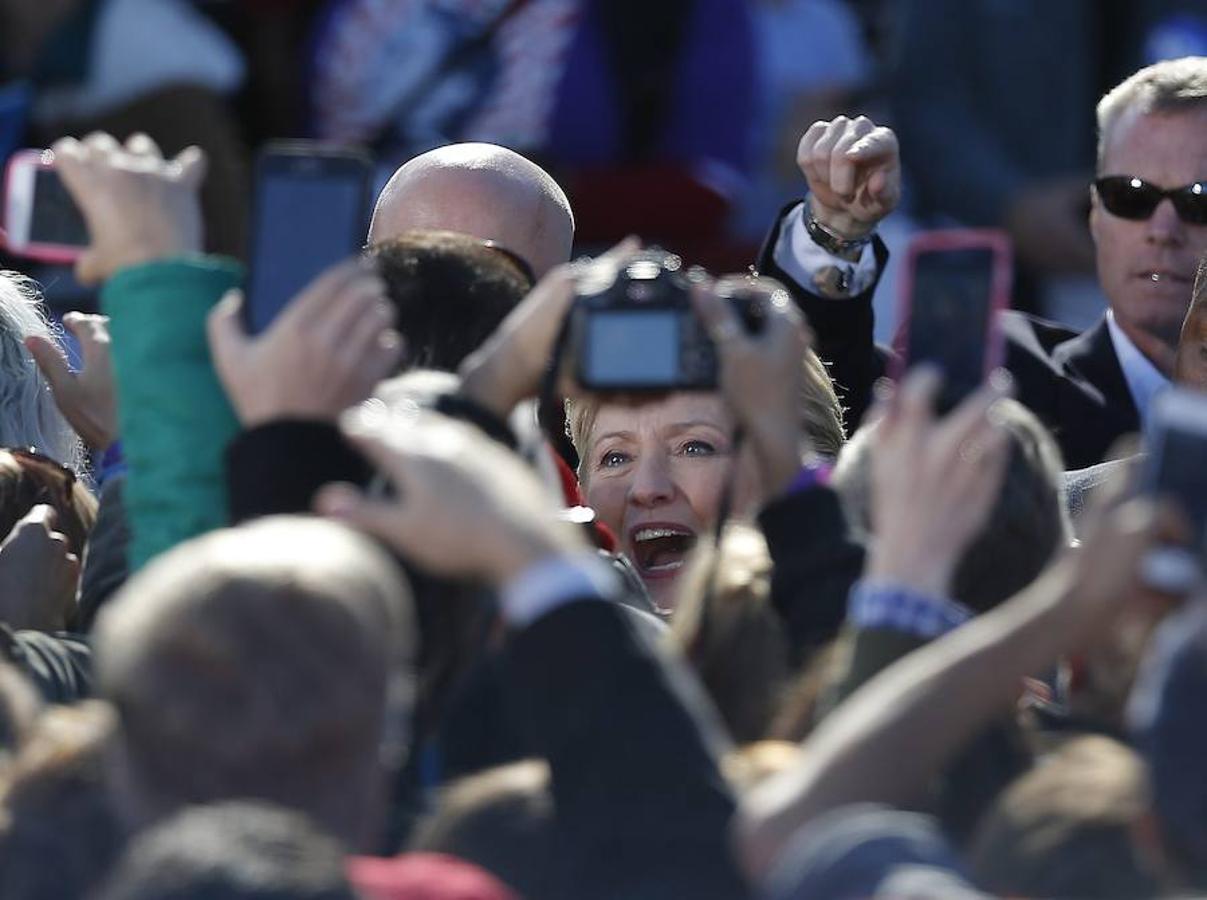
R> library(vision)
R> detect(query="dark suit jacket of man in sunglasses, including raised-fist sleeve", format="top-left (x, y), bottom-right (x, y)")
top-left (758, 204), bottom-right (1139, 468)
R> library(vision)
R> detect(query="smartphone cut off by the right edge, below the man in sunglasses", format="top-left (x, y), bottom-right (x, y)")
top-left (1141, 387), bottom-right (1207, 594)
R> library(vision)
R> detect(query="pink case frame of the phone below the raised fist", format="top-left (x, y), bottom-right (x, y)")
top-left (888, 228), bottom-right (1014, 381)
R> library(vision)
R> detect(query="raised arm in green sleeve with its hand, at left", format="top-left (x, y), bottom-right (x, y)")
top-left (54, 134), bottom-right (243, 568)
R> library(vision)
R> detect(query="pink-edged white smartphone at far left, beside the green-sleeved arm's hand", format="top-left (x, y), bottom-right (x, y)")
top-left (4, 150), bottom-right (88, 263)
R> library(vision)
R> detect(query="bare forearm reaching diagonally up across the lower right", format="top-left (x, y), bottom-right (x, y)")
top-left (739, 446), bottom-right (1168, 875)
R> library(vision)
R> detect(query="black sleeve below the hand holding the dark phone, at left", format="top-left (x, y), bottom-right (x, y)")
top-left (226, 420), bottom-right (372, 525)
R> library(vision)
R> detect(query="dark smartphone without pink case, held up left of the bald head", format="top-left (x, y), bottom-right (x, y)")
top-left (247, 162), bottom-right (368, 333)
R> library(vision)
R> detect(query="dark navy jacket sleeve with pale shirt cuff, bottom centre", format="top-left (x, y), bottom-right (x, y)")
top-left (507, 601), bottom-right (747, 900)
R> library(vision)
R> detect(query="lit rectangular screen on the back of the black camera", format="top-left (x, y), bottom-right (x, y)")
top-left (583, 310), bottom-right (682, 388)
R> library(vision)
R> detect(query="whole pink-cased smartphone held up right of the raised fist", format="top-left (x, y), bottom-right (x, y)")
top-left (890, 229), bottom-right (1013, 411)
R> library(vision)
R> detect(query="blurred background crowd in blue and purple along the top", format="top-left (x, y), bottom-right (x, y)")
top-left (0, 0), bottom-right (1207, 339)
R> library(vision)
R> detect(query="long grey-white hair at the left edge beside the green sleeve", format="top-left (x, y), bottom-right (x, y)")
top-left (0, 271), bottom-right (84, 474)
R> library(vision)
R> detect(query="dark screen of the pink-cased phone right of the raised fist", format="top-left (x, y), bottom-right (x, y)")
top-left (908, 247), bottom-right (995, 407)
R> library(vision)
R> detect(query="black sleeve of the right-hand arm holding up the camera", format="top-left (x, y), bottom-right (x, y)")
top-left (759, 485), bottom-right (864, 666)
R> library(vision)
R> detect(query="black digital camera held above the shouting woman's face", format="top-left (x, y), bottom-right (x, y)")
top-left (568, 249), bottom-right (765, 392)
